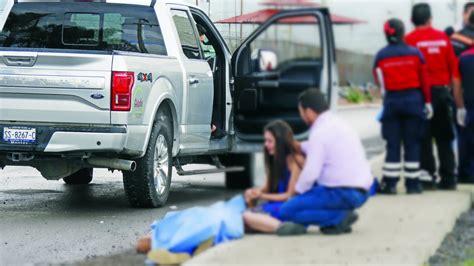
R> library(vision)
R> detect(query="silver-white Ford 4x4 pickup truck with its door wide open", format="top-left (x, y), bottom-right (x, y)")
top-left (0, 0), bottom-right (337, 207)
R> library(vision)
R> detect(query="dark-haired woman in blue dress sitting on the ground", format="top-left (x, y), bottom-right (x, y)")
top-left (244, 120), bottom-right (304, 233)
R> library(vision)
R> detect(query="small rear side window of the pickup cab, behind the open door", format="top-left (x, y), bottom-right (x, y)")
top-left (171, 9), bottom-right (202, 59)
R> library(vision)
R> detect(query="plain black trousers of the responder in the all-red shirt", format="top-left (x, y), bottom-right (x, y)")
top-left (421, 87), bottom-right (456, 184)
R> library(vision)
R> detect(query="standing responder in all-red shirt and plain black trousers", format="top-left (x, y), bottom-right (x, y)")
top-left (405, 3), bottom-right (463, 190)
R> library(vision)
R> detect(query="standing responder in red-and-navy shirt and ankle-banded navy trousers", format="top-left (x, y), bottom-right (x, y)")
top-left (374, 19), bottom-right (433, 194)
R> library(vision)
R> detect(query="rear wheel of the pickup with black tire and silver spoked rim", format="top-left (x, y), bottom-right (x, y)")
top-left (123, 108), bottom-right (173, 208)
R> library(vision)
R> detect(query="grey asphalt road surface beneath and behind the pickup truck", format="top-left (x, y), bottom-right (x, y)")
top-left (0, 109), bottom-right (381, 265)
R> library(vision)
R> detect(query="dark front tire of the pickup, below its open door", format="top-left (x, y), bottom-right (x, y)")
top-left (223, 154), bottom-right (255, 189)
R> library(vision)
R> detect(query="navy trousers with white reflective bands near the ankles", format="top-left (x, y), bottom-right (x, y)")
top-left (382, 89), bottom-right (425, 188)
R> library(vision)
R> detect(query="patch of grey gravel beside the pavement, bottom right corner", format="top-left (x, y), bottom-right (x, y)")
top-left (429, 210), bottom-right (474, 266)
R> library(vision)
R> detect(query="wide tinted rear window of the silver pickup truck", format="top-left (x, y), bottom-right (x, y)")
top-left (0, 3), bottom-right (166, 55)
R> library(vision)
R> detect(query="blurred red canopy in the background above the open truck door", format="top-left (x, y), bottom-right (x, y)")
top-left (215, 8), bottom-right (365, 25)
